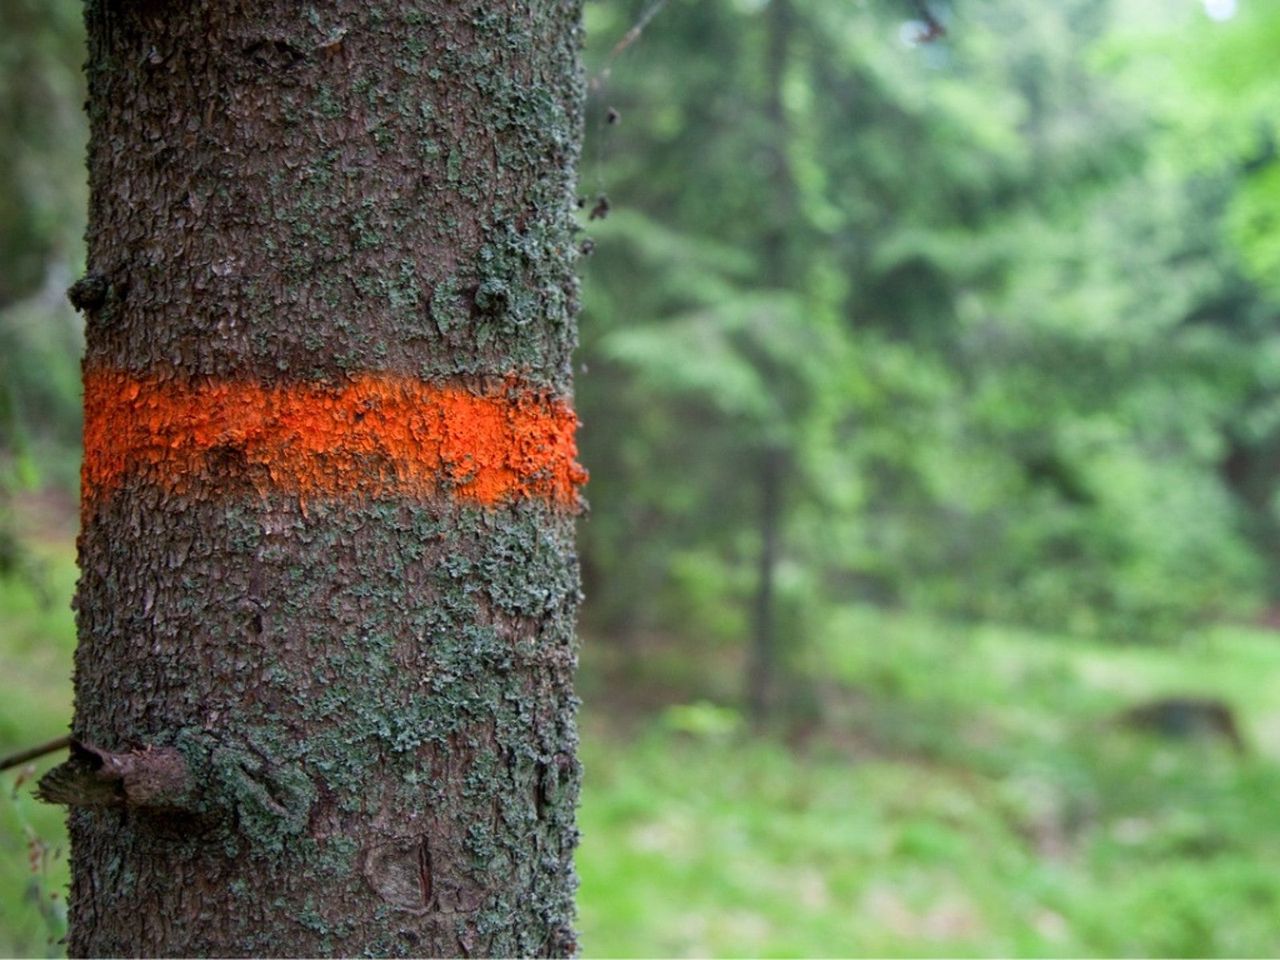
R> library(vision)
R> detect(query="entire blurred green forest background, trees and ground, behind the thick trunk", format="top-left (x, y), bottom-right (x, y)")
top-left (0, 0), bottom-right (1280, 956)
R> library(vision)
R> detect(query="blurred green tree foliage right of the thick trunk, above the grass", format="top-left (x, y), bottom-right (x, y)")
top-left (579, 0), bottom-right (1280, 650)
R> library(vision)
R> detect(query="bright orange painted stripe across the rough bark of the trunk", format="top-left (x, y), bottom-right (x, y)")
top-left (81, 369), bottom-right (586, 508)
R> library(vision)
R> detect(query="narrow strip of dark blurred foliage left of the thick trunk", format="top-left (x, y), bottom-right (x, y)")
top-left (0, 0), bottom-right (86, 563)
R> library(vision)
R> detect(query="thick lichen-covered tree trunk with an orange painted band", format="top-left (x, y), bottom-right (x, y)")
top-left (53, 0), bottom-right (585, 956)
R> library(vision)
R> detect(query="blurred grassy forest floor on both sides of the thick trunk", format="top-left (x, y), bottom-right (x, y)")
top-left (0, 529), bottom-right (1280, 956)
